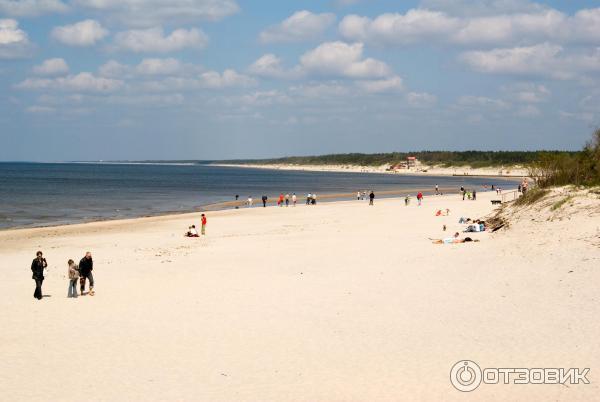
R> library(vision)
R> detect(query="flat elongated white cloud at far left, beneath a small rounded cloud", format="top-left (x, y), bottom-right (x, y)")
top-left (16, 72), bottom-right (123, 92)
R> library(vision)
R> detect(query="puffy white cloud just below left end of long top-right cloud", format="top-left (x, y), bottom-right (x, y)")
top-left (300, 42), bottom-right (391, 78)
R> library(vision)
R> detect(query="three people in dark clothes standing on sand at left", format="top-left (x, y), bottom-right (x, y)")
top-left (31, 251), bottom-right (95, 300)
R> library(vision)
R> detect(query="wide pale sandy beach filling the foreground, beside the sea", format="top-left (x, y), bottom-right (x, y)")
top-left (0, 192), bottom-right (600, 402)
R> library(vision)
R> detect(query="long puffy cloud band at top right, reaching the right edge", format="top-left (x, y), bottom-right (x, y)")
top-left (339, 8), bottom-right (600, 46)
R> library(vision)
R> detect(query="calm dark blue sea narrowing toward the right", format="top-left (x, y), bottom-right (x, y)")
top-left (0, 163), bottom-right (507, 229)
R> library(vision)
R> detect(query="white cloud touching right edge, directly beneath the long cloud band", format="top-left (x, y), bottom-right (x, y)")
top-left (460, 43), bottom-right (600, 79)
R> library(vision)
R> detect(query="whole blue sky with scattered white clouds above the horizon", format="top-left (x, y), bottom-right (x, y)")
top-left (0, 0), bottom-right (600, 161)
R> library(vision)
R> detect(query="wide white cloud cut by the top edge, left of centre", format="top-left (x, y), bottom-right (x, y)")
top-left (73, 0), bottom-right (239, 27)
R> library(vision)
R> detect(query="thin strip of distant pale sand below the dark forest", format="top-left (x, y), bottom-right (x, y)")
top-left (211, 163), bottom-right (529, 179)
